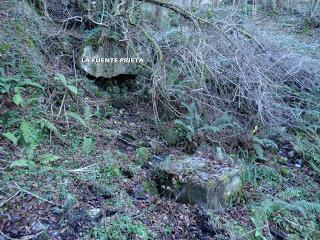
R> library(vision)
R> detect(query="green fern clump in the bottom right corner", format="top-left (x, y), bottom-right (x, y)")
top-left (251, 188), bottom-right (320, 239)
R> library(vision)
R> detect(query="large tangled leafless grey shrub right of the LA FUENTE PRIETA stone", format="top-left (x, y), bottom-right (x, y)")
top-left (20, 0), bottom-right (319, 126)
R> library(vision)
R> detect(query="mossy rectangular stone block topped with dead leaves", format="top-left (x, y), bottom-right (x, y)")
top-left (155, 157), bottom-right (242, 211)
